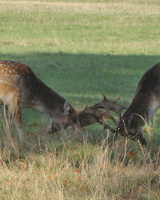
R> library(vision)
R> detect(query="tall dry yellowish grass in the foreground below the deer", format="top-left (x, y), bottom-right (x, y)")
top-left (0, 135), bottom-right (160, 200)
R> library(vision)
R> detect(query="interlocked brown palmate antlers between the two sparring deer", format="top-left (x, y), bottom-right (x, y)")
top-left (78, 95), bottom-right (126, 133)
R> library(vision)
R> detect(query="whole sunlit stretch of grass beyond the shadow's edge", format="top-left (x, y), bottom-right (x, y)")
top-left (0, 1), bottom-right (160, 55)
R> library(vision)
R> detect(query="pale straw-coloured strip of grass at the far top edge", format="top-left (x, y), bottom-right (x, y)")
top-left (0, 1), bottom-right (159, 16)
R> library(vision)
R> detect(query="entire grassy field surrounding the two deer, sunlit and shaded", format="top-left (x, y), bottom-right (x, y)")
top-left (0, 0), bottom-right (160, 200)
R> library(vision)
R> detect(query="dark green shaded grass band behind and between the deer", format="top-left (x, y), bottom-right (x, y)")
top-left (0, 52), bottom-right (160, 106)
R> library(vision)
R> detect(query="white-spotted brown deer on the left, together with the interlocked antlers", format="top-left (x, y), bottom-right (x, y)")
top-left (0, 60), bottom-right (125, 146)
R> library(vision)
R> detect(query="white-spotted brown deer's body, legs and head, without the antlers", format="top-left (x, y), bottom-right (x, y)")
top-left (0, 61), bottom-right (78, 143)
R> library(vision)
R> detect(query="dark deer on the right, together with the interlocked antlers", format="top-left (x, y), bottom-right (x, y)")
top-left (79, 63), bottom-right (160, 145)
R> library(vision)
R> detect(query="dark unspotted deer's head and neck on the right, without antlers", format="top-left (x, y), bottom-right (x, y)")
top-left (117, 63), bottom-right (160, 145)
